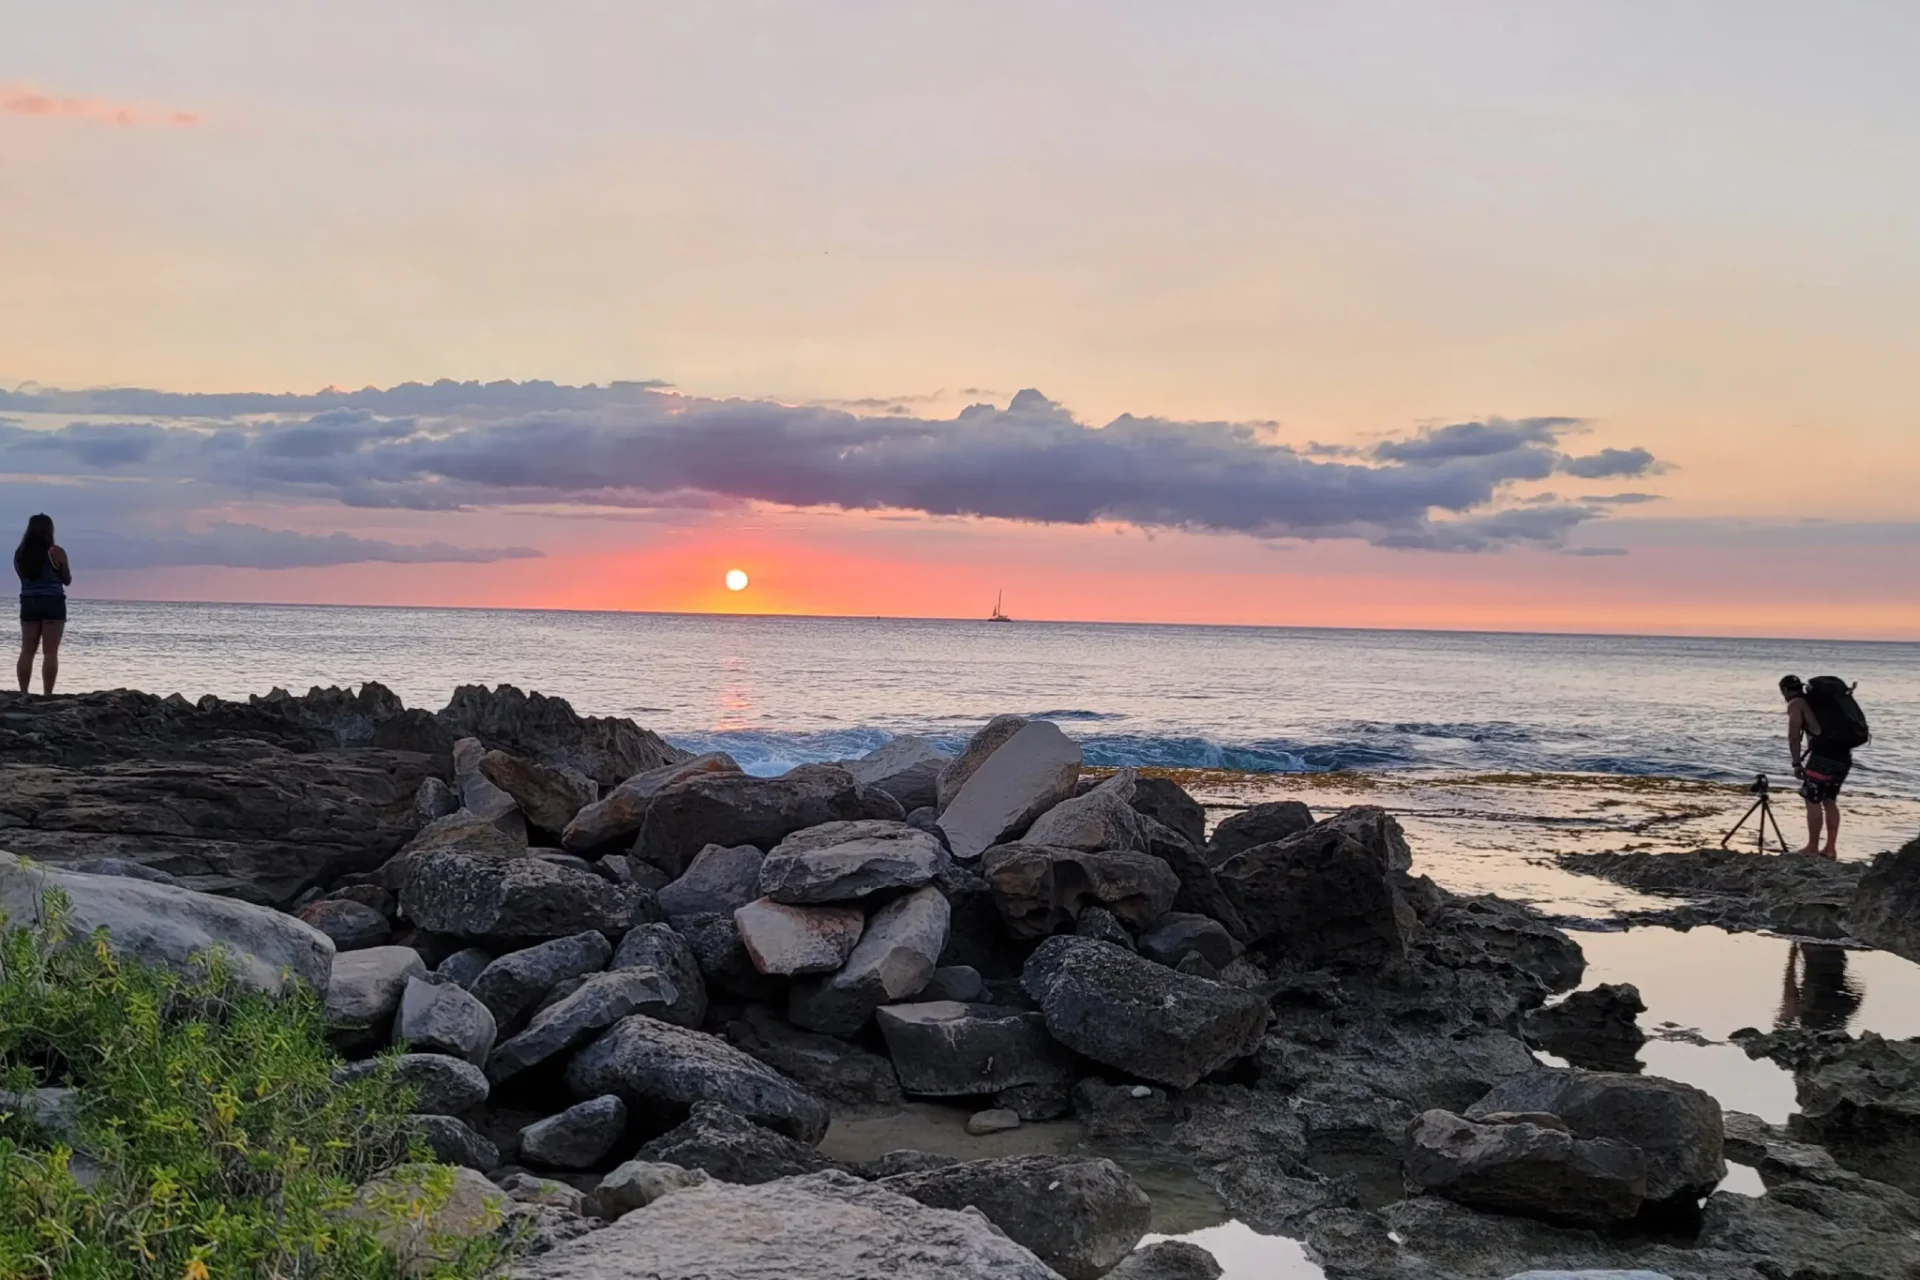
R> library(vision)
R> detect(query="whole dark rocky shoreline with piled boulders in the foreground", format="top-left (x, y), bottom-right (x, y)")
top-left (0, 683), bottom-right (1920, 1280)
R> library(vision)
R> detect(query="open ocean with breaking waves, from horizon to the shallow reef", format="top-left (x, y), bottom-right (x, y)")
top-left (61, 601), bottom-right (1920, 798)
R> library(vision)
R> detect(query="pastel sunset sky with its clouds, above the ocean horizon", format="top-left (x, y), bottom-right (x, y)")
top-left (0, 0), bottom-right (1920, 639)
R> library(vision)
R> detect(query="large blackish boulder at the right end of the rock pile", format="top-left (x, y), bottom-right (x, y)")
top-left (1213, 827), bottom-right (1417, 967)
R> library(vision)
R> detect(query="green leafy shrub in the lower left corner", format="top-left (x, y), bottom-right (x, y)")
top-left (0, 896), bottom-right (503, 1280)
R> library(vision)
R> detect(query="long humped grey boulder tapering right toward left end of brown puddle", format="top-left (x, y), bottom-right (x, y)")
top-left (566, 1015), bottom-right (828, 1142)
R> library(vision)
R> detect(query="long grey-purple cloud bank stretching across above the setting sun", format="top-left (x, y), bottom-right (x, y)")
top-left (0, 382), bottom-right (1659, 564)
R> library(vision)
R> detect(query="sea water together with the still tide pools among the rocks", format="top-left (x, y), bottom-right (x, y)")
top-left (48, 601), bottom-right (1920, 1280)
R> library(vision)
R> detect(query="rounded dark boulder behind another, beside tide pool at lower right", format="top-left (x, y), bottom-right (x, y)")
top-left (1467, 1069), bottom-right (1726, 1203)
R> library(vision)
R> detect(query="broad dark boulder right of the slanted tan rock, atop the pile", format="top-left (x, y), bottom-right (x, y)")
top-left (634, 764), bottom-right (872, 879)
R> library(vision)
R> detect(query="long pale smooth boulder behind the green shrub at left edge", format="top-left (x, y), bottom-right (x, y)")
top-left (0, 852), bottom-right (334, 996)
